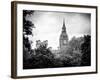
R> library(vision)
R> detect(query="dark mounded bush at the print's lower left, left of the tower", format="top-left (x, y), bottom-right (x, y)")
top-left (24, 40), bottom-right (54, 69)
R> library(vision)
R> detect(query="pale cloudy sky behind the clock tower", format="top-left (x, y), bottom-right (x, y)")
top-left (26, 11), bottom-right (91, 49)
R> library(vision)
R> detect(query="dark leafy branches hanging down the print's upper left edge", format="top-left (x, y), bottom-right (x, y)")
top-left (23, 10), bottom-right (34, 51)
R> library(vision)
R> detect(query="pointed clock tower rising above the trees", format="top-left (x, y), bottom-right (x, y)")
top-left (59, 20), bottom-right (68, 50)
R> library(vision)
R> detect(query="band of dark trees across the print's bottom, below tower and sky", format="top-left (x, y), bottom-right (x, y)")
top-left (23, 35), bottom-right (91, 69)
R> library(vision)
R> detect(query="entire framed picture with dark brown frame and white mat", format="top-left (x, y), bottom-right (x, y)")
top-left (11, 1), bottom-right (97, 78)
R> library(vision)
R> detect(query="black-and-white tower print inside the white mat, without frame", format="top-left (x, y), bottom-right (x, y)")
top-left (23, 10), bottom-right (91, 69)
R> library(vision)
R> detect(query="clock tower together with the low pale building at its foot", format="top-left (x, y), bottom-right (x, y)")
top-left (51, 20), bottom-right (68, 58)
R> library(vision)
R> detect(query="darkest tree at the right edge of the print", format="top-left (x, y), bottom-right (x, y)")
top-left (81, 35), bottom-right (91, 66)
